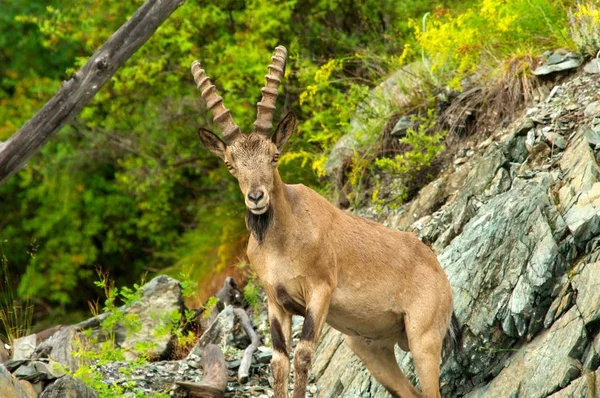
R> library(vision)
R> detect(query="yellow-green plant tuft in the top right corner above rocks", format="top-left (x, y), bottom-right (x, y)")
top-left (569, 0), bottom-right (600, 57)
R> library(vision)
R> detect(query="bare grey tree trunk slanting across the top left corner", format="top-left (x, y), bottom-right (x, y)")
top-left (0, 0), bottom-right (185, 185)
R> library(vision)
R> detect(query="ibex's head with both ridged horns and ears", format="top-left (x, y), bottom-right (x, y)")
top-left (192, 46), bottom-right (296, 215)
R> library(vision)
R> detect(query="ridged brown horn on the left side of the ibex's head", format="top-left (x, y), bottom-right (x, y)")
top-left (192, 61), bottom-right (240, 143)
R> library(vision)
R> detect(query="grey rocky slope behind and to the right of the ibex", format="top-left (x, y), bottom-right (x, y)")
top-left (313, 68), bottom-right (600, 397)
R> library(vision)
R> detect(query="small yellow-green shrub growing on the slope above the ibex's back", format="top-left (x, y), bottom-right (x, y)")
top-left (372, 110), bottom-right (446, 205)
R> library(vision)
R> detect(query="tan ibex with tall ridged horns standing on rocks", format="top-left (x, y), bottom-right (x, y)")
top-left (192, 46), bottom-right (461, 398)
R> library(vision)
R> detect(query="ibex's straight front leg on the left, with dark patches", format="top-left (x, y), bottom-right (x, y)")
top-left (268, 299), bottom-right (292, 398)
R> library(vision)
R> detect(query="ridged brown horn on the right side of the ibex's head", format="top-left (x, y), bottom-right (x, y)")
top-left (254, 46), bottom-right (287, 135)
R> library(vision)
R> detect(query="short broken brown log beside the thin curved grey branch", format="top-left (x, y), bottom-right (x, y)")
top-left (176, 344), bottom-right (227, 398)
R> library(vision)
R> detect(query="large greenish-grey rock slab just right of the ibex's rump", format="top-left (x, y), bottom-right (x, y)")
top-left (438, 175), bottom-right (564, 378)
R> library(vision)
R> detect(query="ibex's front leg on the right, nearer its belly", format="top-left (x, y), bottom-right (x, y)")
top-left (293, 286), bottom-right (331, 398)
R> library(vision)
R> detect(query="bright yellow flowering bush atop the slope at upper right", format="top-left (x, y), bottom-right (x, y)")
top-left (412, 0), bottom-right (566, 89)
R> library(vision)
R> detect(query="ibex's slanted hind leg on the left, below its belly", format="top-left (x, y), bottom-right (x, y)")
top-left (345, 336), bottom-right (422, 398)
